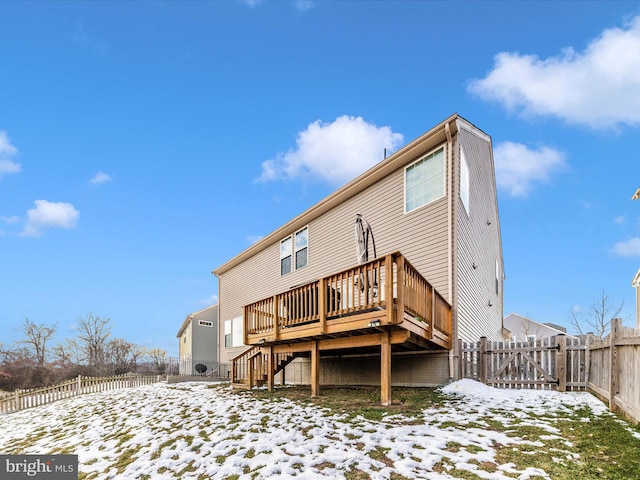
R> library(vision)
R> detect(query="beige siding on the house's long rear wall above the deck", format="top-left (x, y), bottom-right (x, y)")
top-left (219, 144), bottom-right (449, 363)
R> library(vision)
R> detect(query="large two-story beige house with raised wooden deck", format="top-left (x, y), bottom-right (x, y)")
top-left (213, 114), bottom-right (504, 404)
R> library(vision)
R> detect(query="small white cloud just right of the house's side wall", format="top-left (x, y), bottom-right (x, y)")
top-left (493, 142), bottom-right (567, 197)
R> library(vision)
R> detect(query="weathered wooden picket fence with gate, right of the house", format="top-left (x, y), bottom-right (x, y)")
top-left (458, 318), bottom-right (640, 422)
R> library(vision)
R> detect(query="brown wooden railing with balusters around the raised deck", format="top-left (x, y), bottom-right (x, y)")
top-left (244, 252), bottom-right (451, 345)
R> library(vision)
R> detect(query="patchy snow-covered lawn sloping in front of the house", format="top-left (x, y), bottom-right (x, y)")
top-left (0, 380), bottom-right (624, 480)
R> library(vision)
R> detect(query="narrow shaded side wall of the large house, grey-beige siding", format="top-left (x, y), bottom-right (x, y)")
top-left (454, 122), bottom-right (503, 341)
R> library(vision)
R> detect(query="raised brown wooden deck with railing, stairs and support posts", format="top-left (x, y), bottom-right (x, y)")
top-left (232, 252), bottom-right (452, 403)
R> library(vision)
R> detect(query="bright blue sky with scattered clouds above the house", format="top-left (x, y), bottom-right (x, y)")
top-left (0, 1), bottom-right (640, 355)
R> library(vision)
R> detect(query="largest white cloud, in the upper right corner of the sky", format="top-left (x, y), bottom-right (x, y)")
top-left (469, 16), bottom-right (640, 128)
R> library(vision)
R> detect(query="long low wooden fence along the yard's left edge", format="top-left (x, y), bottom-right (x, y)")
top-left (0, 374), bottom-right (160, 414)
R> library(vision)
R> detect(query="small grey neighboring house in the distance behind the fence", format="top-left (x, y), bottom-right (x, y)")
top-left (176, 305), bottom-right (218, 375)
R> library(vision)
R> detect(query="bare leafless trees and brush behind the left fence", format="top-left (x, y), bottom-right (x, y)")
top-left (0, 313), bottom-right (167, 391)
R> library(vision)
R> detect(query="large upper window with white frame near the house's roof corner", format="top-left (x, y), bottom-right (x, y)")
top-left (404, 147), bottom-right (444, 213)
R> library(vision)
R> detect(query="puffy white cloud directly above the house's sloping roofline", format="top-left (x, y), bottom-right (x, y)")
top-left (258, 115), bottom-right (403, 184)
